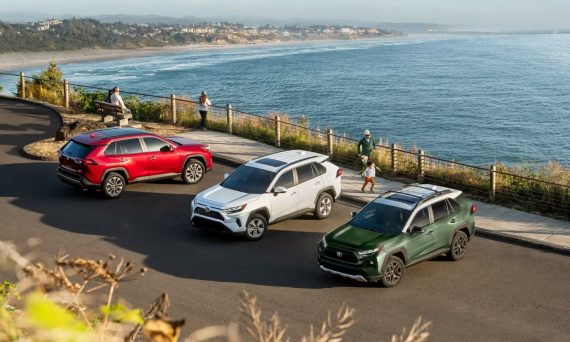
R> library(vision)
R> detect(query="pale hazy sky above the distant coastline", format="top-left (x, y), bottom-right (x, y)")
top-left (4, 0), bottom-right (570, 30)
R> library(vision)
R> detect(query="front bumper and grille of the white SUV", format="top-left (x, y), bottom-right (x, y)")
top-left (190, 204), bottom-right (249, 234)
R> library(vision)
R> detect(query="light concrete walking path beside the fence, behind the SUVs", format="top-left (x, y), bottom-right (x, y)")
top-left (178, 131), bottom-right (570, 254)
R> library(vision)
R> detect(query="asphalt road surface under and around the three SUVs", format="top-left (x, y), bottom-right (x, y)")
top-left (0, 100), bottom-right (570, 341)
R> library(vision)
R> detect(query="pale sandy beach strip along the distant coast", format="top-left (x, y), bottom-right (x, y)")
top-left (0, 36), bottom-right (405, 72)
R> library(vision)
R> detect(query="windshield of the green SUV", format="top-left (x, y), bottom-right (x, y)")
top-left (350, 202), bottom-right (411, 234)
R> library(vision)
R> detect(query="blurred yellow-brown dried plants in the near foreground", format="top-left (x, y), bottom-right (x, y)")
top-left (0, 241), bottom-right (430, 342)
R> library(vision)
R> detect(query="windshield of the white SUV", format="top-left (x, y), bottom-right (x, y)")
top-left (221, 165), bottom-right (275, 194)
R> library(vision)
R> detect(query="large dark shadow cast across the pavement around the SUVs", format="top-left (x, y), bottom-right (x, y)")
top-left (0, 162), bottom-right (359, 288)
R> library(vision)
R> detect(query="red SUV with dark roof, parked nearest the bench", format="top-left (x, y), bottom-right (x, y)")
top-left (57, 128), bottom-right (212, 198)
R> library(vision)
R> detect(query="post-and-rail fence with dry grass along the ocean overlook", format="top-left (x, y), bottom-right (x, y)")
top-left (0, 72), bottom-right (570, 219)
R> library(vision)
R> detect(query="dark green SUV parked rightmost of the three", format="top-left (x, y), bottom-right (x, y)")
top-left (318, 184), bottom-right (477, 287)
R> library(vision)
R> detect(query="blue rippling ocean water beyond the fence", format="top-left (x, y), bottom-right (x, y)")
top-left (0, 34), bottom-right (570, 166)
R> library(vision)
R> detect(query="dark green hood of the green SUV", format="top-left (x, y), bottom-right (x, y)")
top-left (327, 223), bottom-right (398, 250)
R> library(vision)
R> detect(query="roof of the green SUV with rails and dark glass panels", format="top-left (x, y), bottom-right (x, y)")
top-left (375, 184), bottom-right (461, 210)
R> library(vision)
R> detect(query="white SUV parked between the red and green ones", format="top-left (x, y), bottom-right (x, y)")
top-left (190, 150), bottom-right (342, 240)
